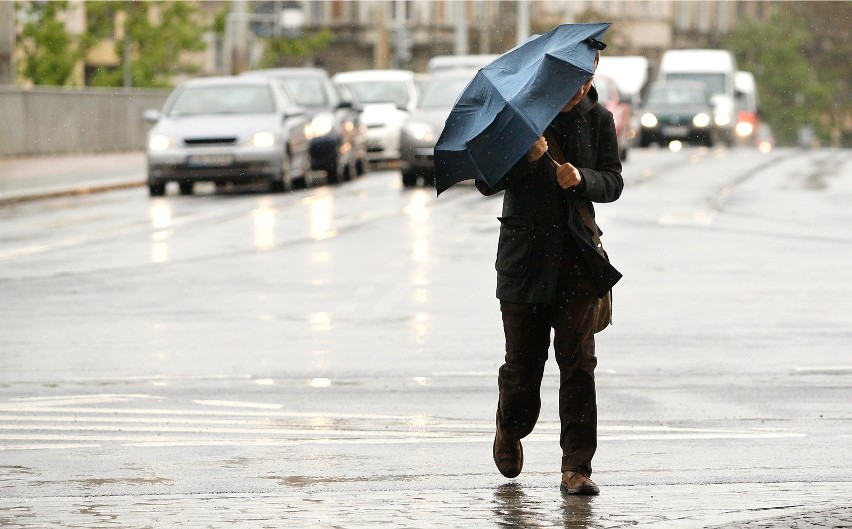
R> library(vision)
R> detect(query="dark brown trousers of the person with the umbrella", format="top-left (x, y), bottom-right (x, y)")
top-left (497, 250), bottom-right (597, 476)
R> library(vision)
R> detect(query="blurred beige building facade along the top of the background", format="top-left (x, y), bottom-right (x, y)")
top-left (0, 0), bottom-right (778, 85)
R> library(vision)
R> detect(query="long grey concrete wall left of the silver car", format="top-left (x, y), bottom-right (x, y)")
top-left (0, 86), bottom-right (169, 156)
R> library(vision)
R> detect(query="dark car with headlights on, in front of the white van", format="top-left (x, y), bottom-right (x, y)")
top-left (639, 81), bottom-right (715, 147)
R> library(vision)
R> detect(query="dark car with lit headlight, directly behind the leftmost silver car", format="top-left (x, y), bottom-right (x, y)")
top-left (242, 68), bottom-right (366, 183)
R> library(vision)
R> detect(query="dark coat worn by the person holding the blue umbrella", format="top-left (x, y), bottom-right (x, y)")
top-left (476, 89), bottom-right (624, 303)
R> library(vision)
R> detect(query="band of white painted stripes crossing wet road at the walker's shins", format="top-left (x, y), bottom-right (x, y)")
top-left (0, 402), bottom-right (806, 450)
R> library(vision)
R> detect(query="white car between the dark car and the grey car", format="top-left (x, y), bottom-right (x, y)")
top-left (331, 70), bottom-right (417, 162)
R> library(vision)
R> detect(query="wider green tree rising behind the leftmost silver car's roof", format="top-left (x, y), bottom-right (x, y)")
top-left (85, 0), bottom-right (206, 87)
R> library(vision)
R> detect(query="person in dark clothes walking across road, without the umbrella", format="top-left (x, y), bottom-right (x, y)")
top-left (476, 52), bottom-right (624, 494)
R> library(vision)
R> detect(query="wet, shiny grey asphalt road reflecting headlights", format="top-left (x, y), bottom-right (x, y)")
top-left (0, 149), bottom-right (852, 527)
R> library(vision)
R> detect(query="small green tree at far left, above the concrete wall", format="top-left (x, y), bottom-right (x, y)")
top-left (17, 1), bottom-right (83, 86)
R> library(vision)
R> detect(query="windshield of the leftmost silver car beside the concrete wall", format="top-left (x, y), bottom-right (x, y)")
top-left (168, 85), bottom-right (275, 116)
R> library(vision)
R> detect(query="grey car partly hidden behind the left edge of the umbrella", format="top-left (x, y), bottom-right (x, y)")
top-left (399, 70), bottom-right (476, 187)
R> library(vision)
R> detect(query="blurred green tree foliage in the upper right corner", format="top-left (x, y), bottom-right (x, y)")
top-left (725, 2), bottom-right (852, 143)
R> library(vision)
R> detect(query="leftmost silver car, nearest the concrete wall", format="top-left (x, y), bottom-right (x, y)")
top-left (145, 77), bottom-right (310, 196)
